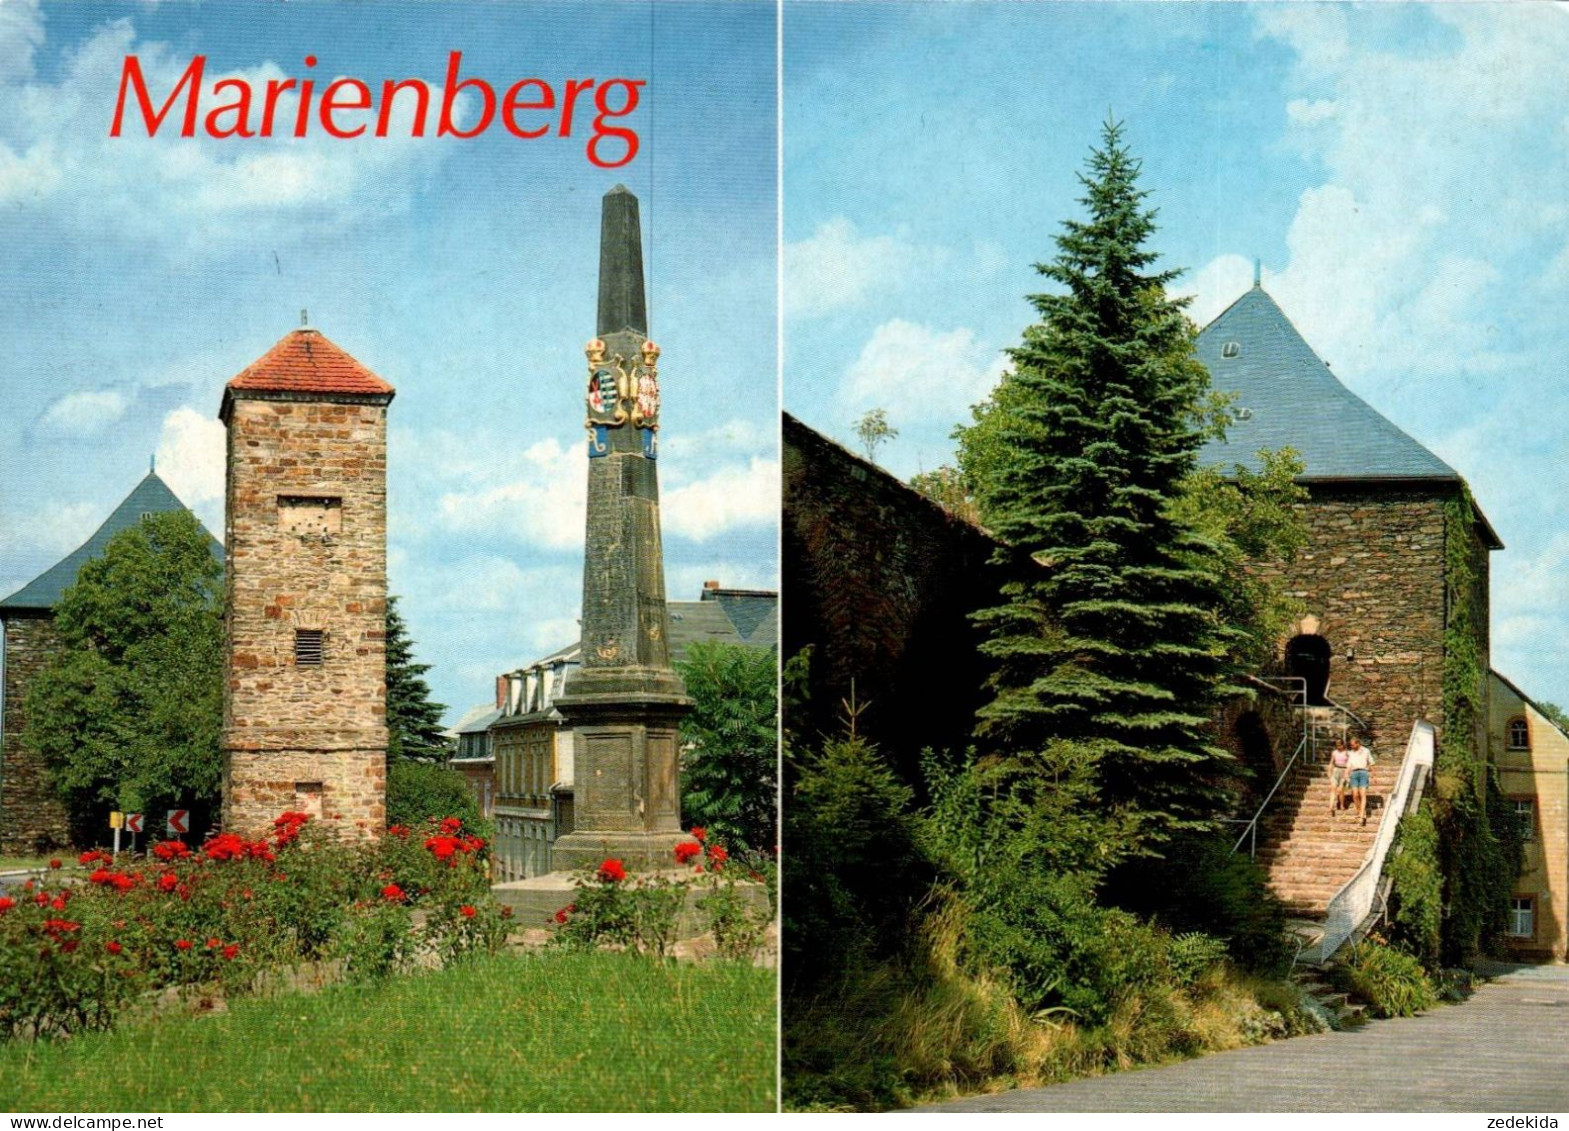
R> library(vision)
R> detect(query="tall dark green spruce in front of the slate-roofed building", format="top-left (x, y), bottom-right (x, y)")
top-left (960, 122), bottom-right (1238, 852)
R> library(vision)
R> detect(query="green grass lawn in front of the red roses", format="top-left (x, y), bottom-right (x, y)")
top-left (0, 952), bottom-right (775, 1112)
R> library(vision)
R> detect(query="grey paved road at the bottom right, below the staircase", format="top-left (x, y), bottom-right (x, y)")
top-left (923, 966), bottom-right (1569, 1115)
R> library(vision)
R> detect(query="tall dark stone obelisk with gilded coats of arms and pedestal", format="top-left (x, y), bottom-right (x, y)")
top-left (552, 185), bottom-right (690, 869)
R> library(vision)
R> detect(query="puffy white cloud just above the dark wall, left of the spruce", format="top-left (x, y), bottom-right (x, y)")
top-left (839, 318), bottom-right (1006, 427)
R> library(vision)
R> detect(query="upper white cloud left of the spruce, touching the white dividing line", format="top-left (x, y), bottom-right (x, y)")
top-left (785, 216), bottom-right (946, 318)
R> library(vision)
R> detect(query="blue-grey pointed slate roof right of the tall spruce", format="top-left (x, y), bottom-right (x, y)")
top-left (1196, 282), bottom-right (1503, 549)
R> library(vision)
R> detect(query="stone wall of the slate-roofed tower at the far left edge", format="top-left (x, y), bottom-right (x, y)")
top-left (0, 613), bottom-right (71, 853)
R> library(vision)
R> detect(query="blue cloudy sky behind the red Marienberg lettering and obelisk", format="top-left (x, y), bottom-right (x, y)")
top-left (0, 0), bottom-right (778, 717)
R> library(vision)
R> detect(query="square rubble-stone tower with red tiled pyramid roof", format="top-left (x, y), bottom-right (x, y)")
top-left (218, 329), bottom-right (394, 836)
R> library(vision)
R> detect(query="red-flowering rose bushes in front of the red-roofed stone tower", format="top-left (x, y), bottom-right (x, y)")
top-left (0, 814), bottom-right (508, 1042)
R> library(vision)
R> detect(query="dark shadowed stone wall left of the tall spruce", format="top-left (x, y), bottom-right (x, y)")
top-left (781, 416), bottom-right (1025, 783)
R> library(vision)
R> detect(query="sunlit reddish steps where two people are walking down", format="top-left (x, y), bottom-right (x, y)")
top-left (1257, 727), bottom-right (1400, 921)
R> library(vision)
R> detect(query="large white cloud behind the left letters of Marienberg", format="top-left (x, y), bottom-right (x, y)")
top-left (0, 19), bottom-right (463, 257)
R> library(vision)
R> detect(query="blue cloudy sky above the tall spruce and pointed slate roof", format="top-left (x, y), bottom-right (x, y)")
top-left (783, 3), bottom-right (1569, 715)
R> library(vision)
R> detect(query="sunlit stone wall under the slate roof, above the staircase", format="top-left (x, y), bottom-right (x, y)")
top-left (1248, 486), bottom-right (1456, 758)
